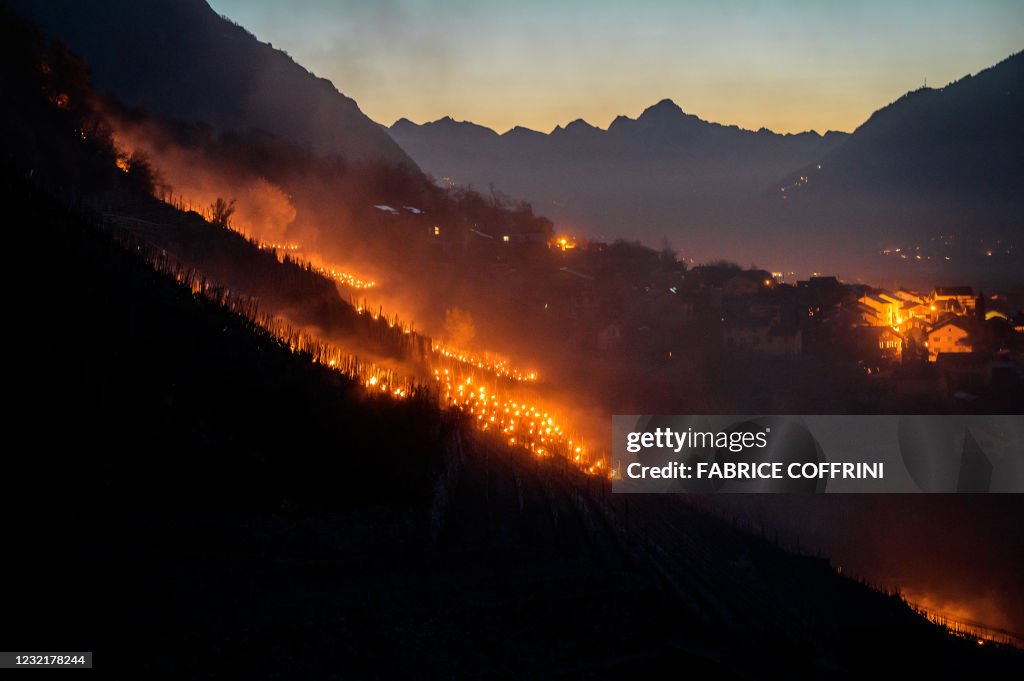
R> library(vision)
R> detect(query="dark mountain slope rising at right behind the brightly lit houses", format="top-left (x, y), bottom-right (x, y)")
top-left (765, 52), bottom-right (1024, 286)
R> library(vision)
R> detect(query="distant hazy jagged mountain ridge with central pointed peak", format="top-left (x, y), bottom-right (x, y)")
top-left (390, 99), bottom-right (846, 258)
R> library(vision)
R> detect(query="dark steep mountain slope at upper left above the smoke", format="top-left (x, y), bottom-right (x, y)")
top-left (11, 0), bottom-right (413, 165)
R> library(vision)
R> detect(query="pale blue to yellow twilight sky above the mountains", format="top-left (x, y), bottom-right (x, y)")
top-left (209, 0), bottom-right (1024, 132)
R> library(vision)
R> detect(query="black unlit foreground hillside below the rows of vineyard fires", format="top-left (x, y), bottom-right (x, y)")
top-left (0, 177), bottom-right (1024, 679)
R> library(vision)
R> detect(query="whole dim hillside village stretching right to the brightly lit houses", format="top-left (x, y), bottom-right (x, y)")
top-left (356, 201), bottom-right (1024, 410)
